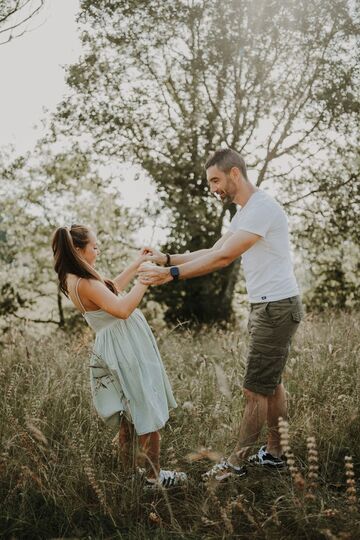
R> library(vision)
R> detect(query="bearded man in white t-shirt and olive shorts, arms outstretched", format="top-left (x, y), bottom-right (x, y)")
top-left (140, 149), bottom-right (302, 481)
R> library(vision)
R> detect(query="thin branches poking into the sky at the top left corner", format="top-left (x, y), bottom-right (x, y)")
top-left (0, 0), bottom-right (45, 45)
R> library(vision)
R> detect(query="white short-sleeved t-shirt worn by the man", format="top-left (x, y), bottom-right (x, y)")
top-left (229, 191), bottom-right (299, 303)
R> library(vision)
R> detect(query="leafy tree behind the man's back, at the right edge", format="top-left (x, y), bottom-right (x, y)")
top-left (287, 140), bottom-right (360, 311)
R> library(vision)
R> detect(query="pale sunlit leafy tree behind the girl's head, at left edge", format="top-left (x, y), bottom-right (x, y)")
top-left (0, 141), bottom-right (135, 327)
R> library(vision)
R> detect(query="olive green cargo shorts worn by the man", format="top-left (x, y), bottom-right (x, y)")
top-left (244, 296), bottom-right (304, 395)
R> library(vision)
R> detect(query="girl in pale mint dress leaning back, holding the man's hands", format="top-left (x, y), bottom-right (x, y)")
top-left (52, 225), bottom-right (186, 487)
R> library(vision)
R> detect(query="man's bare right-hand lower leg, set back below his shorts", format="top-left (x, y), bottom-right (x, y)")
top-left (266, 384), bottom-right (287, 457)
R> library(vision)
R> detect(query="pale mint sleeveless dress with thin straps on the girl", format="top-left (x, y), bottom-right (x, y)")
top-left (75, 278), bottom-right (177, 435)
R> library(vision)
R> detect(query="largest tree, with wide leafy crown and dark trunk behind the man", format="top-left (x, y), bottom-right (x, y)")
top-left (54, 0), bottom-right (359, 322)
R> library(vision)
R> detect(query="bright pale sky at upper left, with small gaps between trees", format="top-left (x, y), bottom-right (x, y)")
top-left (0, 0), bottom-right (163, 241)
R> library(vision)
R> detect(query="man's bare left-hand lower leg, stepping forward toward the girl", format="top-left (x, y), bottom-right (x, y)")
top-left (228, 388), bottom-right (269, 465)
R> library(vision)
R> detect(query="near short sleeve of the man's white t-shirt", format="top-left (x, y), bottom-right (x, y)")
top-left (229, 204), bottom-right (276, 237)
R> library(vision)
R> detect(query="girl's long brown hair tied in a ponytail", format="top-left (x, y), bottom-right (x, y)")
top-left (52, 225), bottom-right (117, 296)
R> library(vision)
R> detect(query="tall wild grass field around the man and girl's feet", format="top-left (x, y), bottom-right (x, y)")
top-left (0, 313), bottom-right (360, 540)
